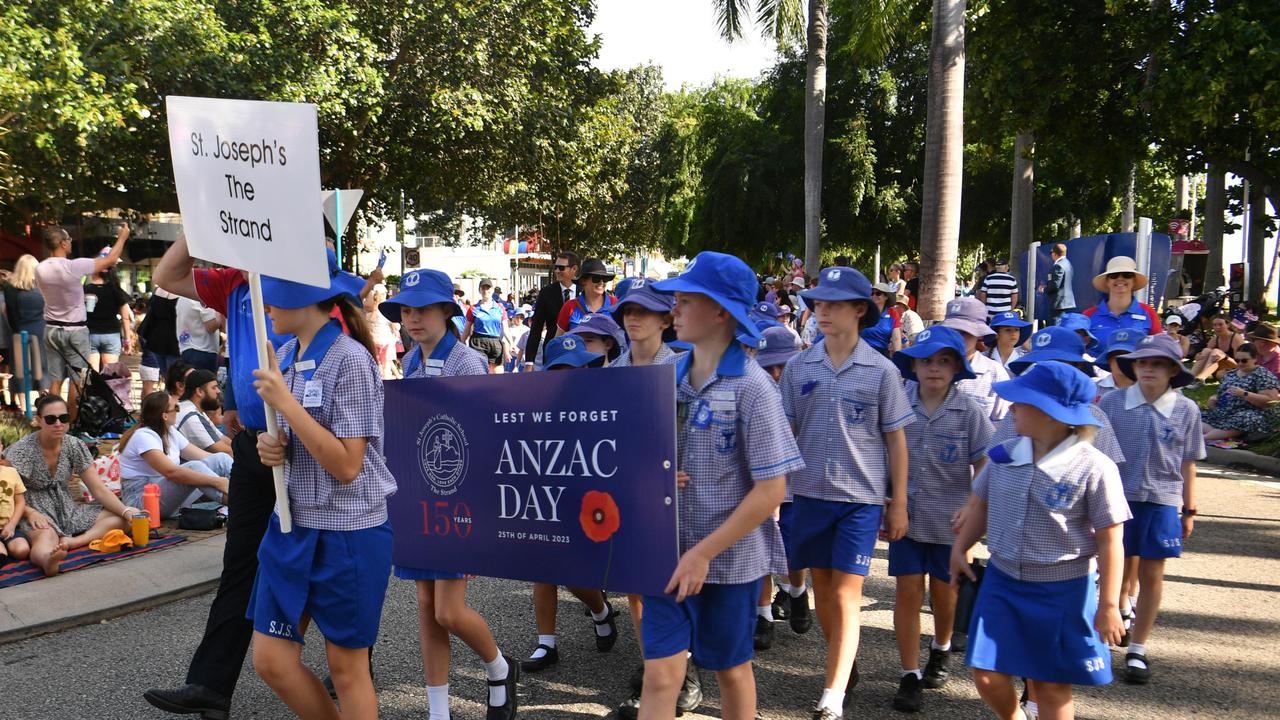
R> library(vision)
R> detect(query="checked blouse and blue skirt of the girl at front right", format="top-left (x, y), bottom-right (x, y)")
top-left (965, 436), bottom-right (1129, 685)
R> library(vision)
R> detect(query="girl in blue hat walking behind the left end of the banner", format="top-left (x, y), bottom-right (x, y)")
top-left (378, 270), bottom-right (520, 720)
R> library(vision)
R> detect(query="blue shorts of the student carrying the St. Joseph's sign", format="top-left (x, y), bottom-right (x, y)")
top-left (246, 515), bottom-right (392, 648)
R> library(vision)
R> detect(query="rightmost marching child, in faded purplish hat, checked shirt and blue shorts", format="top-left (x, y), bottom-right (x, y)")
top-left (1101, 331), bottom-right (1204, 685)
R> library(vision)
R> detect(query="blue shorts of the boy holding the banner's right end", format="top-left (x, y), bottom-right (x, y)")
top-left (640, 580), bottom-right (760, 671)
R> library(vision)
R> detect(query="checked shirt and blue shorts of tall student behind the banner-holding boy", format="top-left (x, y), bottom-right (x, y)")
top-left (778, 341), bottom-right (915, 575)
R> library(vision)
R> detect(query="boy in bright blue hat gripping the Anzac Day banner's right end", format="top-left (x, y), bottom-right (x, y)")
top-left (639, 252), bottom-right (804, 720)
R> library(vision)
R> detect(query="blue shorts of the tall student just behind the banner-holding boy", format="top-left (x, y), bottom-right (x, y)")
top-left (787, 495), bottom-right (884, 577)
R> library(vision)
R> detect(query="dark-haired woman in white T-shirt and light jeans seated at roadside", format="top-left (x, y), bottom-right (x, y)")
top-left (118, 389), bottom-right (232, 519)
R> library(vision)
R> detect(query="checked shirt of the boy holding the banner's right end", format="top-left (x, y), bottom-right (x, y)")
top-left (668, 342), bottom-right (804, 584)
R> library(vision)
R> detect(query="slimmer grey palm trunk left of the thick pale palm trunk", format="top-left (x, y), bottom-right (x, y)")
top-left (804, 0), bottom-right (827, 277)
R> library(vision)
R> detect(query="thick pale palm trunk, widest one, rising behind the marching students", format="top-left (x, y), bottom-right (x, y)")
top-left (916, 0), bottom-right (965, 320)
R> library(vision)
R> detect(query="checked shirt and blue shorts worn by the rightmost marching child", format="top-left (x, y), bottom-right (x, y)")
top-left (1101, 384), bottom-right (1204, 560)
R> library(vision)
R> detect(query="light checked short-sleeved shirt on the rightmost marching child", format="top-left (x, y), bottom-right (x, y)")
top-left (1100, 384), bottom-right (1204, 507)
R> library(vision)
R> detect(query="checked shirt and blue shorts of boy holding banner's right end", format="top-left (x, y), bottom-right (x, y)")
top-left (640, 342), bottom-right (804, 670)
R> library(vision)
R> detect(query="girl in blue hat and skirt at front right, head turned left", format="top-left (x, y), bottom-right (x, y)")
top-left (951, 360), bottom-right (1129, 720)
